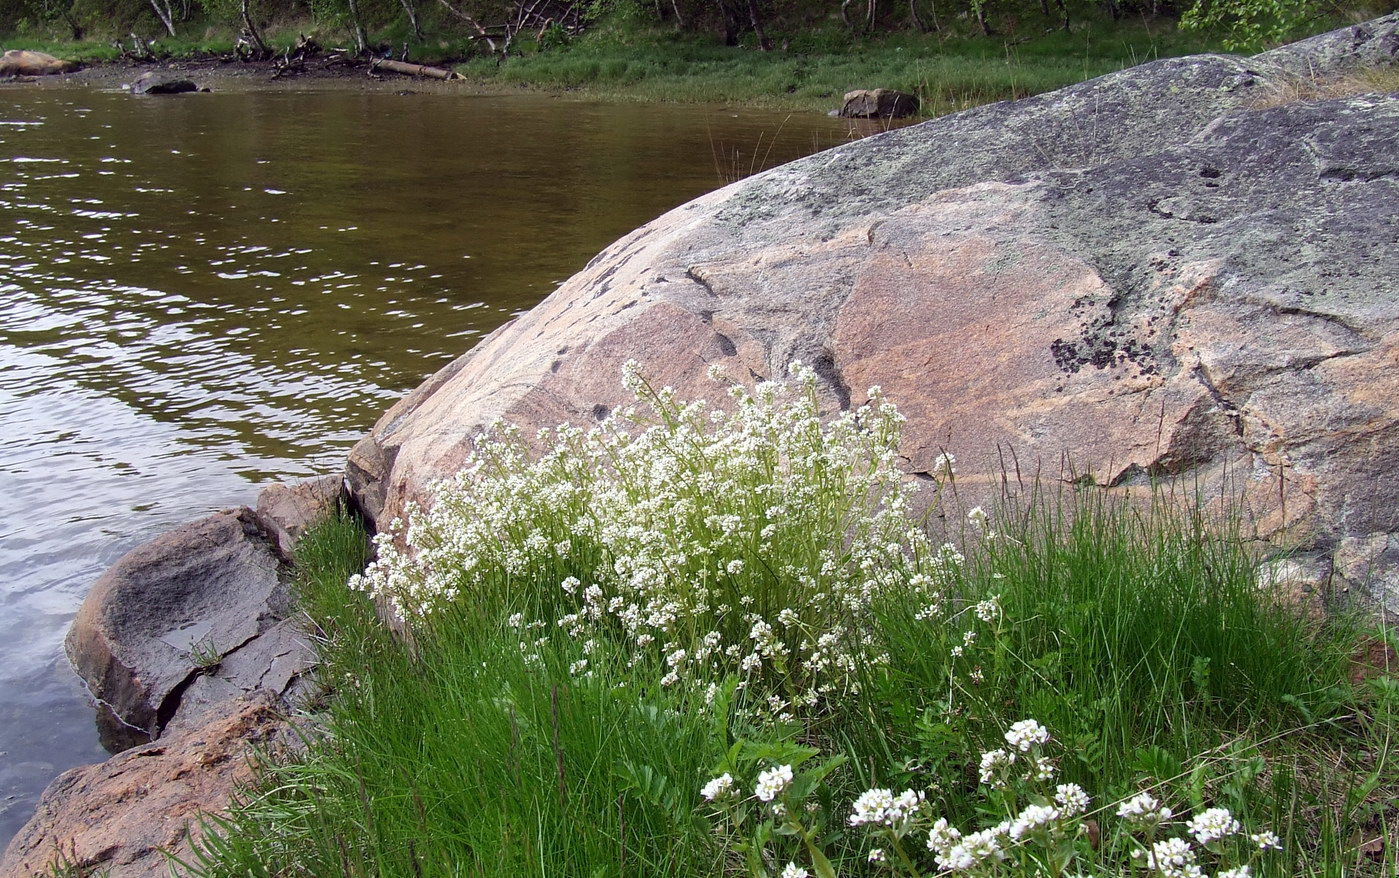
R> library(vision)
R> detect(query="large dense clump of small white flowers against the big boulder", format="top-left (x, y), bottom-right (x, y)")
top-left (351, 364), bottom-right (945, 717)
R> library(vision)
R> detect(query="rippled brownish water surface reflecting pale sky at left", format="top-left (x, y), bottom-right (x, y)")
top-left (0, 87), bottom-right (849, 846)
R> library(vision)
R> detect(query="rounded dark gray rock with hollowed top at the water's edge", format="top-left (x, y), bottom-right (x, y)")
top-left (67, 508), bottom-right (308, 748)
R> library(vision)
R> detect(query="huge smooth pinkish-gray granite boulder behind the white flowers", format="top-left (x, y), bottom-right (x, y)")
top-left (347, 15), bottom-right (1399, 608)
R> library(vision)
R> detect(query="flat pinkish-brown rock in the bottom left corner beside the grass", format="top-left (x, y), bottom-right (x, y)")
top-left (0, 691), bottom-right (297, 878)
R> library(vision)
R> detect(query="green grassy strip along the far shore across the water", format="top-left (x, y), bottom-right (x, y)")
top-left (4, 18), bottom-right (1219, 116)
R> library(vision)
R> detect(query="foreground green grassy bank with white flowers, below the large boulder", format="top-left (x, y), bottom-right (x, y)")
top-left (180, 370), bottom-right (1399, 878)
